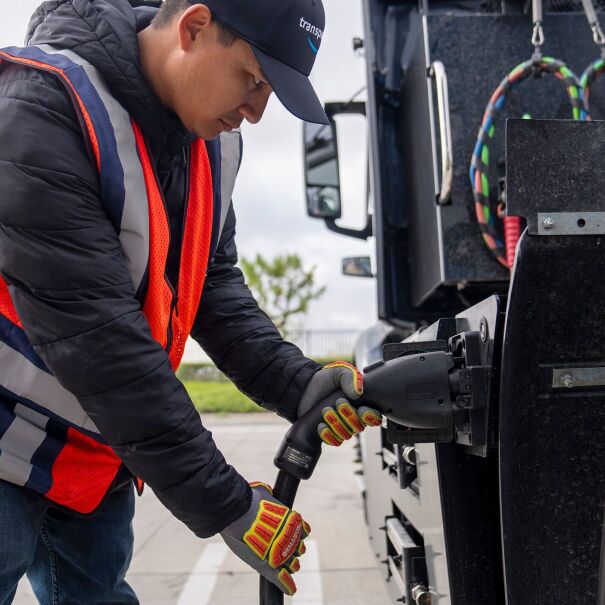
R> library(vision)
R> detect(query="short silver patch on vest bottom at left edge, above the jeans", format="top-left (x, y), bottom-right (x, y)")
top-left (0, 403), bottom-right (48, 485)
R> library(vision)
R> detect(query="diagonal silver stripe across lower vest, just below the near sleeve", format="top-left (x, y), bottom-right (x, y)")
top-left (0, 344), bottom-right (99, 433)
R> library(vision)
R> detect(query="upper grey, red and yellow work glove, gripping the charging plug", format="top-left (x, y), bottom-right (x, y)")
top-left (297, 361), bottom-right (382, 446)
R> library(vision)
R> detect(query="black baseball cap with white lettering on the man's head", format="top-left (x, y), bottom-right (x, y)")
top-left (203, 0), bottom-right (329, 124)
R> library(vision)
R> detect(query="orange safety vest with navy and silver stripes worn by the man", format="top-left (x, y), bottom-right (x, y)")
top-left (0, 45), bottom-right (232, 513)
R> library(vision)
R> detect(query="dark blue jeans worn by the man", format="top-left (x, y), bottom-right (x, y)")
top-left (0, 481), bottom-right (139, 605)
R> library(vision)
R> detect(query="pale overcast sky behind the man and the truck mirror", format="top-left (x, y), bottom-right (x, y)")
top-left (0, 0), bottom-right (376, 329)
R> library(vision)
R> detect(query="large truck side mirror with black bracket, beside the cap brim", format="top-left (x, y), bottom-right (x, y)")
top-left (304, 102), bottom-right (372, 239)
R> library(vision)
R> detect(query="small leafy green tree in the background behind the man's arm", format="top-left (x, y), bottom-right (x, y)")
top-left (241, 254), bottom-right (326, 334)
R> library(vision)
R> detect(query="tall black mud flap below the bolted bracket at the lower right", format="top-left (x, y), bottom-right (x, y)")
top-left (500, 230), bottom-right (605, 605)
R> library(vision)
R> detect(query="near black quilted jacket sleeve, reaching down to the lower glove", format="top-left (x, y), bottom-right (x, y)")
top-left (0, 66), bottom-right (251, 537)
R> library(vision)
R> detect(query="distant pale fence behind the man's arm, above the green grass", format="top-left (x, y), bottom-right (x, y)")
top-left (183, 329), bottom-right (360, 363)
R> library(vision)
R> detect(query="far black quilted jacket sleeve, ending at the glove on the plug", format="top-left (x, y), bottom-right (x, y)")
top-left (192, 206), bottom-right (321, 422)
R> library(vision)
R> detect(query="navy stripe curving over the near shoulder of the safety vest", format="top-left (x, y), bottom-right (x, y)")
top-left (4, 46), bottom-right (125, 233)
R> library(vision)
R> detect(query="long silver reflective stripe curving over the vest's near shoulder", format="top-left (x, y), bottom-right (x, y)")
top-left (38, 44), bottom-right (149, 292)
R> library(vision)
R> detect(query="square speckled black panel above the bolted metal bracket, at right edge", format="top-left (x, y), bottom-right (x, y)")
top-left (506, 120), bottom-right (605, 233)
